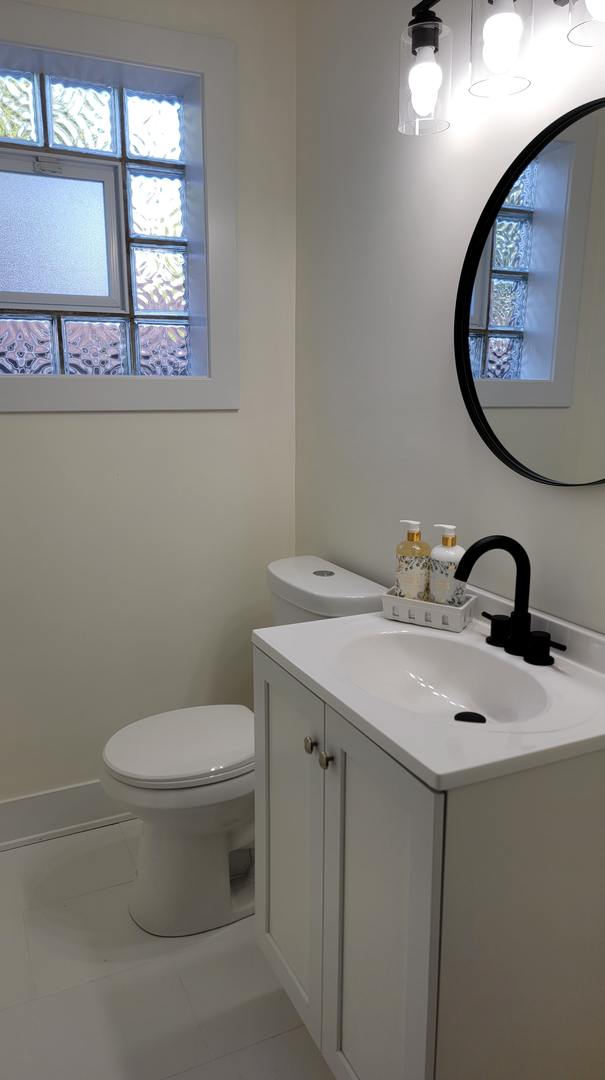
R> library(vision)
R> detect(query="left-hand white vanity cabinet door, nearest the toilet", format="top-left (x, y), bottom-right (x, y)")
top-left (254, 649), bottom-right (324, 1044)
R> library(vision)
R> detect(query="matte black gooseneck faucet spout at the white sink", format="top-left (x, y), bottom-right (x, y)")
top-left (455, 536), bottom-right (532, 657)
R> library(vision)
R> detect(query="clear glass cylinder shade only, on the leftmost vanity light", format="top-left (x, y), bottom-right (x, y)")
top-left (399, 25), bottom-right (452, 135)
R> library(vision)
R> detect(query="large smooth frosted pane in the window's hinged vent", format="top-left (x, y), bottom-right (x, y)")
top-left (0, 172), bottom-right (109, 297)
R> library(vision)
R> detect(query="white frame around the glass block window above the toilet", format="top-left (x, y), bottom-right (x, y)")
top-left (0, 0), bottom-right (239, 411)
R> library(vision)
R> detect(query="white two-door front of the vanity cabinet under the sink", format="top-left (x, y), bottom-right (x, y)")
top-left (255, 649), bottom-right (444, 1080)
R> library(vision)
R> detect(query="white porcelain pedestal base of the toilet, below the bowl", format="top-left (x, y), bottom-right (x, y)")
top-left (129, 821), bottom-right (254, 937)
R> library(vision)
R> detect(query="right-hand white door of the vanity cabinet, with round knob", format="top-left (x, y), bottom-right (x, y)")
top-left (322, 708), bottom-right (444, 1080)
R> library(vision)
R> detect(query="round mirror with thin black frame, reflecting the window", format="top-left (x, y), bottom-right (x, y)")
top-left (455, 98), bottom-right (605, 485)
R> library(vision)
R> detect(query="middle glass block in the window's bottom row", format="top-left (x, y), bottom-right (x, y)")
top-left (63, 319), bottom-right (129, 375)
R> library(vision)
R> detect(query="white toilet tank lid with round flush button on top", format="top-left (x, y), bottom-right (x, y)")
top-left (267, 555), bottom-right (387, 618)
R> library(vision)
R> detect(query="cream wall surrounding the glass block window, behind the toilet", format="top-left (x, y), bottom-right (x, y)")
top-left (0, 0), bottom-right (295, 799)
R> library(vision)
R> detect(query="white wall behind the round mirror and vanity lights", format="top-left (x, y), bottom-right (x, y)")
top-left (297, 0), bottom-right (605, 631)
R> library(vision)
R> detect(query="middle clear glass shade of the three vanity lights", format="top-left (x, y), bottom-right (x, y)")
top-left (469, 0), bottom-right (531, 97)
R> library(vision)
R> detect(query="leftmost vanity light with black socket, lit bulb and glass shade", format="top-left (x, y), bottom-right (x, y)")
top-left (399, 0), bottom-right (452, 135)
